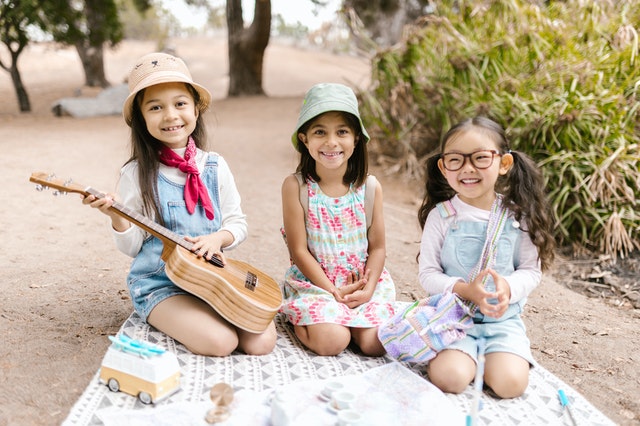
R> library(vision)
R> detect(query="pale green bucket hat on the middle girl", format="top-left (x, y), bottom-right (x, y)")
top-left (291, 83), bottom-right (370, 150)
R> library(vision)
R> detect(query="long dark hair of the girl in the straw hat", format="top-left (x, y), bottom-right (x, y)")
top-left (125, 83), bottom-right (207, 225)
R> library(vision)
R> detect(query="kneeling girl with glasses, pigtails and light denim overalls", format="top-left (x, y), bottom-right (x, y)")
top-left (418, 117), bottom-right (555, 398)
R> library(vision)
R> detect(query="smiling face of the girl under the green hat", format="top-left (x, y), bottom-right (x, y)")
top-left (298, 111), bottom-right (356, 173)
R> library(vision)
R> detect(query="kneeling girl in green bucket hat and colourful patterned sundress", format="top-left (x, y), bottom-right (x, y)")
top-left (281, 83), bottom-right (395, 356)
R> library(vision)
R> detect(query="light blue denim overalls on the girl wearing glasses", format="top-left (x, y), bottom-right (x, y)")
top-left (438, 205), bottom-right (534, 364)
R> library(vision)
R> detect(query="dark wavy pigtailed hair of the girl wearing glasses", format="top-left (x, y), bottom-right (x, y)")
top-left (418, 116), bottom-right (555, 271)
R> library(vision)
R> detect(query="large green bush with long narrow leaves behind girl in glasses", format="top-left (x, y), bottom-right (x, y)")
top-left (361, 0), bottom-right (640, 257)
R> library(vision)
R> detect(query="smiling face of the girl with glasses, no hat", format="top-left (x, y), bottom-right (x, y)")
top-left (438, 129), bottom-right (513, 210)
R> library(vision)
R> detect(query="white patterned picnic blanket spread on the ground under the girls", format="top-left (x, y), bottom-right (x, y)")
top-left (63, 313), bottom-right (614, 426)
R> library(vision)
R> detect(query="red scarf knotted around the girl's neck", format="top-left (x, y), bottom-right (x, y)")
top-left (160, 136), bottom-right (213, 220)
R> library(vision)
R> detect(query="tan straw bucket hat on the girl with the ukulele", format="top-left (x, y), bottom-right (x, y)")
top-left (122, 52), bottom-right (211, 126)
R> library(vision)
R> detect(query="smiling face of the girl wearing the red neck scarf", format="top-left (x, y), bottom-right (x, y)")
top-left (140, 83), bottom-right (199, 149)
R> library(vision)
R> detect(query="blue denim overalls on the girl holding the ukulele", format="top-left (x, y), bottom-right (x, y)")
top-left (127, 154), bottom-right (222, 321)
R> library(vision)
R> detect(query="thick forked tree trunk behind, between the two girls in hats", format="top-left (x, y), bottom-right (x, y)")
top-left (227, 0), bottom-right (271, 97)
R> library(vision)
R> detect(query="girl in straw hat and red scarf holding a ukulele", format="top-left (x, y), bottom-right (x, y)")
top-left (83, 53), bottom-right (276, 356)
